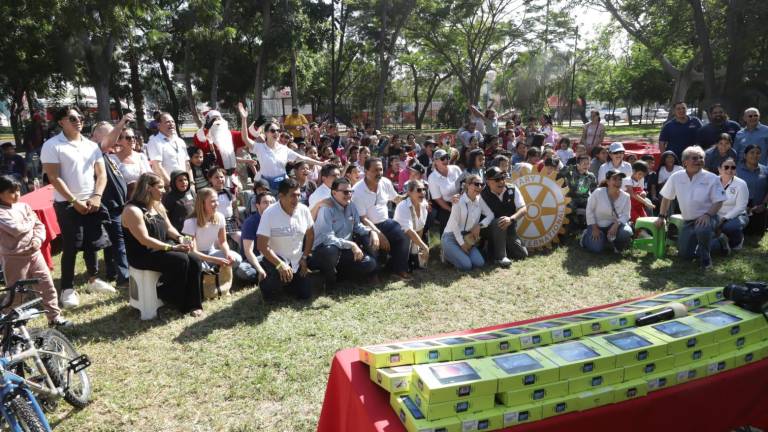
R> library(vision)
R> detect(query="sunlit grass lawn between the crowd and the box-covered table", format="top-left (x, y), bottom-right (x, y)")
top-left (34, 228), bottom-right (768, 431)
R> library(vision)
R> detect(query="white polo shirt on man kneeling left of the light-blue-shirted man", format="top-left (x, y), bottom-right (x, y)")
top-left (256, 201), bottom-right (314, 272)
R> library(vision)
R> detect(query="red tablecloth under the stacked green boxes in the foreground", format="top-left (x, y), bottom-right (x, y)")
top-left (318, 302), bottom-right (768, 432)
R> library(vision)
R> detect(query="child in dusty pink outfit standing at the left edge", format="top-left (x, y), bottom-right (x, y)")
top-left (0, 176), bottom-right (72, 327)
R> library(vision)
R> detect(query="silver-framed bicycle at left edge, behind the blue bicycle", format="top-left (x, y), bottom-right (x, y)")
top-left (0, 279), bottom-right (92, 418)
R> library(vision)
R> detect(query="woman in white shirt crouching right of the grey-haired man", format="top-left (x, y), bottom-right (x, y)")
top-left (712, 158), bottom-right (749, 254)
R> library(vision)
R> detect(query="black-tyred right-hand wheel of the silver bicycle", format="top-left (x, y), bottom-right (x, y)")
top-left (38, 329), bottom-right (93, 408)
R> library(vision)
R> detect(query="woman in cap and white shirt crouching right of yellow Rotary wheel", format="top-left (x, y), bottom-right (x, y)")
top-left (581, 169), bottom-right (632, 253)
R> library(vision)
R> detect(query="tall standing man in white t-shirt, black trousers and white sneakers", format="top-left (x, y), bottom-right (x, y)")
top-left (40, 106), bottom-right (109, 308)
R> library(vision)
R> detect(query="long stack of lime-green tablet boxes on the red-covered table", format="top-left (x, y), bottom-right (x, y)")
top-left (360, 288), bottom-right (768, 432)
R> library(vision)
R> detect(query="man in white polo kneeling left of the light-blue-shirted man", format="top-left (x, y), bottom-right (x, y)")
top-left (256, 178), bottom-right (315, 300)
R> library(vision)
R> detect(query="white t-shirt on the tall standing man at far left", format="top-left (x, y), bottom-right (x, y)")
top-left (40, 132), bottom-right (104, 202)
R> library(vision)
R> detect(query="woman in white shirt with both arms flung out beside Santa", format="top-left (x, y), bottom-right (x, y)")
top-left (242, 122), bottom-right (322, 193)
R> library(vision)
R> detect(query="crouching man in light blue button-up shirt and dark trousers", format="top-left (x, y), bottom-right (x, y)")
top-left (309, 177), bottom-right (377, 288)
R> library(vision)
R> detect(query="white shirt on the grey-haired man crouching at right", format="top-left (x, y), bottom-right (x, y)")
top-left (660, 169), bottom-right (726, 221)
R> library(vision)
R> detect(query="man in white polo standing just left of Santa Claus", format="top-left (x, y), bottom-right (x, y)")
top-left (147, 113), bottom-right (195, 186)
